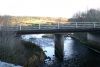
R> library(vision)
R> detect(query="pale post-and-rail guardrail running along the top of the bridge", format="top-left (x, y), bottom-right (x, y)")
top-left (0, 22), bottom-right (100, 31)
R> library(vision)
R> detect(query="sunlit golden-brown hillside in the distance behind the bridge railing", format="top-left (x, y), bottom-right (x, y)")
top-left (0, 16), bottom-right (68, 25)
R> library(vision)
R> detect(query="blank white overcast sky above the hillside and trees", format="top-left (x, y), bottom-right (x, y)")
top-left (0, 0), bottom-right (100, 18)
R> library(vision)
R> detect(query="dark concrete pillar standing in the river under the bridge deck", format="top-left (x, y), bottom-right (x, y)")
top-left (55, 34), bottom-right (64, 61)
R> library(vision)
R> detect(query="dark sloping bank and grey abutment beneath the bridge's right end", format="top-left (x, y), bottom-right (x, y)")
top-left (72, 33), bottom-right (100, 53)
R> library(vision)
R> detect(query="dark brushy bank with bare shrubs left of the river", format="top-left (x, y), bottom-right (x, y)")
top-left (0, 31), bottom-right (45, 67)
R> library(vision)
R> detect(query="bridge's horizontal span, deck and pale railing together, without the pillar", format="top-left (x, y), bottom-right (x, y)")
top-left (0, 22), bottom-right (100, 34)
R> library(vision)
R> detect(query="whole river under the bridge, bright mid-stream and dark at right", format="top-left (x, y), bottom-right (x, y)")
top-left (0, 34), bottom-right (100, 67)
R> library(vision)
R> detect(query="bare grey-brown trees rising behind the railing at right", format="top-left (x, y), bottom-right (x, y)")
top-left (69, 9), bottom-right (100, 22)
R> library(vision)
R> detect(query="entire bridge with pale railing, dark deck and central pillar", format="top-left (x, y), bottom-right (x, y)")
top-left (0, 22), bottom-right (100, 60)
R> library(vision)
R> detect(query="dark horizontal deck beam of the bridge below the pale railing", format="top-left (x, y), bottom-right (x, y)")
top-left (16, 28), bottom-right (100, 35)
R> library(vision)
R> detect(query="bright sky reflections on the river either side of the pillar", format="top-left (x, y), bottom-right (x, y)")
top-left (21, 35), bottom-right (73, 64)
